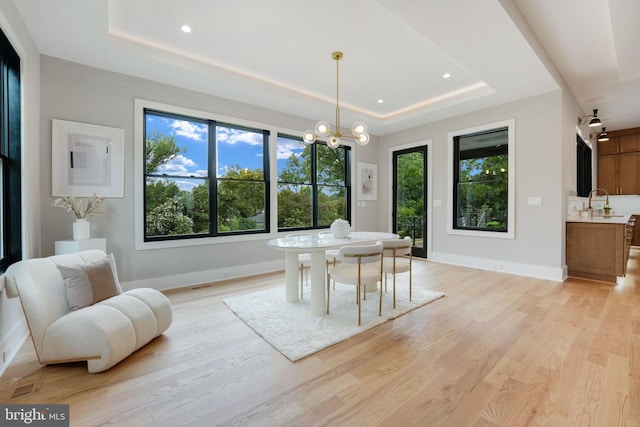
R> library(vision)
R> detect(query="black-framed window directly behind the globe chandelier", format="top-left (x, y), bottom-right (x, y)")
top-left (277, 135), bottom-right (351, 230)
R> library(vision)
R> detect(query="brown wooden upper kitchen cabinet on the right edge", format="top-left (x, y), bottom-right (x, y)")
top-left (597, 128), bottom-right (640, 195)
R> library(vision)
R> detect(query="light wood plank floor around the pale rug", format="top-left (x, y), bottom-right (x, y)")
top-left (0, 249), bottom-right (640, 427)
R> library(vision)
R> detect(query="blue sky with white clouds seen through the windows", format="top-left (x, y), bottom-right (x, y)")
top-left (146, 115), bottom-right (304, 189)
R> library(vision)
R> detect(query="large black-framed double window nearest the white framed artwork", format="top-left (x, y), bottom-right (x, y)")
top-left (143, 109), bottom-right (269, 241)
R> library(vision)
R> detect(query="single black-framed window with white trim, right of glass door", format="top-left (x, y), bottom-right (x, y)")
top-left (449, 121), bottom-right (515, 238)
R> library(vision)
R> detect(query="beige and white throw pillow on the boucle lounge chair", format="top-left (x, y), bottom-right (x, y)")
top-left (58, 254), bottom-right (122, 311)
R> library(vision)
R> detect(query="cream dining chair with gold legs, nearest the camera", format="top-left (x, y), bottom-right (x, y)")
top-left (327, 242), bottom-right (383, 326)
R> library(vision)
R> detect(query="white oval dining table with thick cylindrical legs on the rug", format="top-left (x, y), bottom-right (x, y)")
top-left (267, 231), bottom-right (398, 316)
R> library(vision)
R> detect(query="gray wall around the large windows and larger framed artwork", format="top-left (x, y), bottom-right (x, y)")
top-left (40, 56), bottom-right (378, 289)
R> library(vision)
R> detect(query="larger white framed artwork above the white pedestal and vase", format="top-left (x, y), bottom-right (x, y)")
top-left (51, 119), bottom-right (124, 197)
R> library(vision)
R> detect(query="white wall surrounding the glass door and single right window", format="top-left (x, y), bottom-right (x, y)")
top-left (378, 91), bottom-right (575, 280)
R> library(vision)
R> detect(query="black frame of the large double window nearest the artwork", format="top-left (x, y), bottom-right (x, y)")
top-left (142, 107), bottom-right (271, 243)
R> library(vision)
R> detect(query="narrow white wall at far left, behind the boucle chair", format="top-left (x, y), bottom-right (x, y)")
top-left (0, 0), bottom-right (41, 374)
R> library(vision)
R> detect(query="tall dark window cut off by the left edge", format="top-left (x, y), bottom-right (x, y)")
top-left (0, 31), bottom-right (22, 272)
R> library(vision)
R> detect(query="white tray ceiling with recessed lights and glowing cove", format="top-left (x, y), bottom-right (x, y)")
top-left (14, 0), bottom-right (640, 135)
